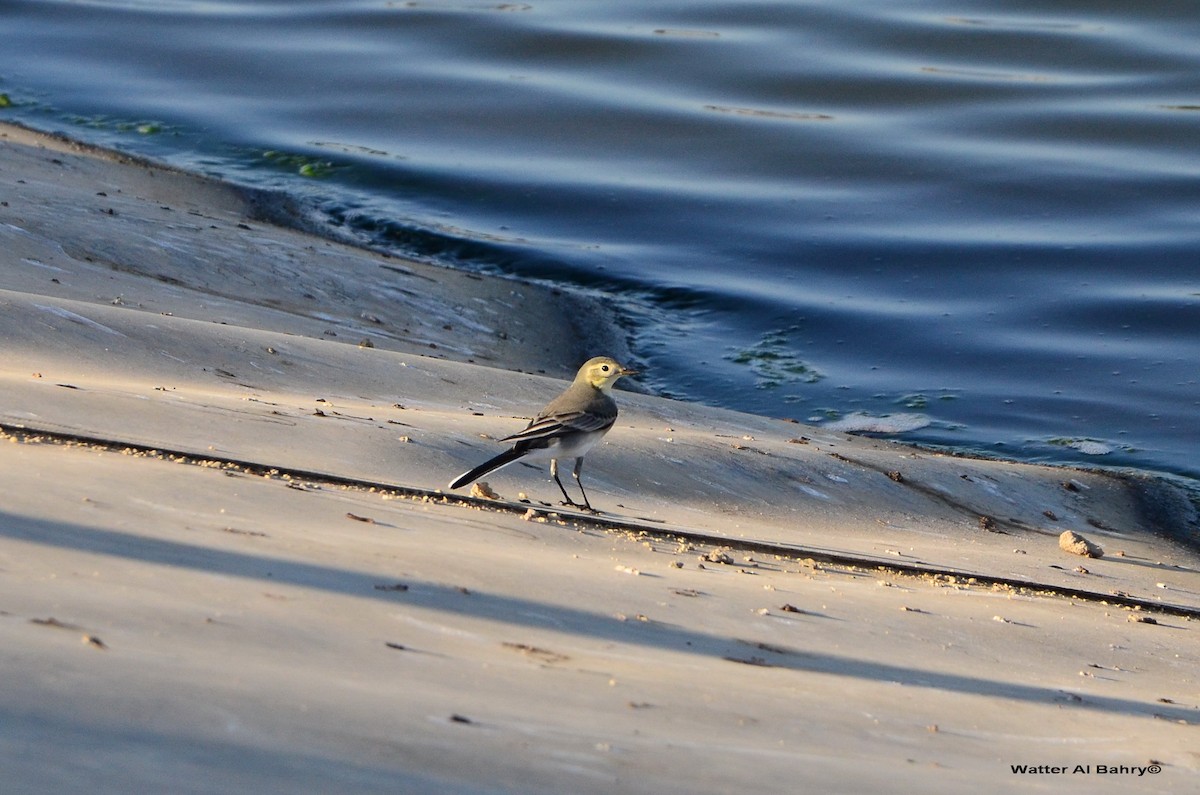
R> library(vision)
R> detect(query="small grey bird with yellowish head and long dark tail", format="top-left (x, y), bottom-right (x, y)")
top-left (450, 357), bottom-right (637, 513)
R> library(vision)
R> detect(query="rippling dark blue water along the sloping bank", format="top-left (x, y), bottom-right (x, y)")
top-left (0, 0), bottom-right (1200, 489)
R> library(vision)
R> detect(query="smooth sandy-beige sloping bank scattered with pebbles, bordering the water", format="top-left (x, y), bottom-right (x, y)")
top-left (0, 126), bottom-right (1200, 793)
